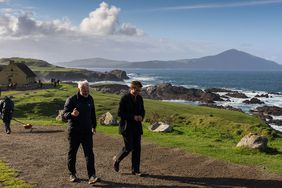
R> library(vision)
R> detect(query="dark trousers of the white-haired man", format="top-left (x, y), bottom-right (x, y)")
top-left (68, 131), bottom-right (96, 178)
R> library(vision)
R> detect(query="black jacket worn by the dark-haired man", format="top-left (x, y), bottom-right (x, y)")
top-left (118, 93), bottom-right (145, 135)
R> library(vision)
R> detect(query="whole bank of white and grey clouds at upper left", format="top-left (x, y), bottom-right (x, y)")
top-left (0, 2), bottom-right (144, 38)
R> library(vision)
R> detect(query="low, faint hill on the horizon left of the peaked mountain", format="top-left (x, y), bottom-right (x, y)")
top-left (56, 58), bottom-right (129, 68)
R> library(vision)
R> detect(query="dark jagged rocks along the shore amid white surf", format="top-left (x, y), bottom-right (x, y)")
top-left (91, 83), bottom-right (282, 131)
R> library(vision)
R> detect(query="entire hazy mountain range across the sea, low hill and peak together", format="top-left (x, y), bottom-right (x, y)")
top-left (58, 49), bottom-right (282, 71)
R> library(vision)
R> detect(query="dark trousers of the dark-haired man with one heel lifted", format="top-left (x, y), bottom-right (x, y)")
top-left (116, 131), bottom-right (141, 172)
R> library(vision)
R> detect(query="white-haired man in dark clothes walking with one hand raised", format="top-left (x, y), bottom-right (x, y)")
top-left (63, 80), bottom-right (100, 184)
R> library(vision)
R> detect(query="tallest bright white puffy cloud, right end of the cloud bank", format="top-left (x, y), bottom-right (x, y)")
top-left (80, 2), bottom-right (144, 36)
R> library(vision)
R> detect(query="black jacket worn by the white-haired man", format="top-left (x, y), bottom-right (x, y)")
top-left (63, 92), bottom-right (97, 132)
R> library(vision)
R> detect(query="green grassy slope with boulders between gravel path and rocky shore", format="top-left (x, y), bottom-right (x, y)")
top-left (0, 85), bottom-right (282, 187)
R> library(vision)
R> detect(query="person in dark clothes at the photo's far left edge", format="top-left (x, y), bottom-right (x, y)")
top-left (0, 96), bottom-right (14, 134)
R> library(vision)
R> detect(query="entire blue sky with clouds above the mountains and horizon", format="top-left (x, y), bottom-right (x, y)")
top-left (0, 0), bottom-right (282, 64)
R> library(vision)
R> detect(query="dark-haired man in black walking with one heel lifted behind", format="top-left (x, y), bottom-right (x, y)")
top-left (113, 81), bottom-right (145, 176)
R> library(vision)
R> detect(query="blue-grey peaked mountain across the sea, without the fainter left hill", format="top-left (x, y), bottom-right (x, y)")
top-left (126, 49), bottom-right (282, 71)
